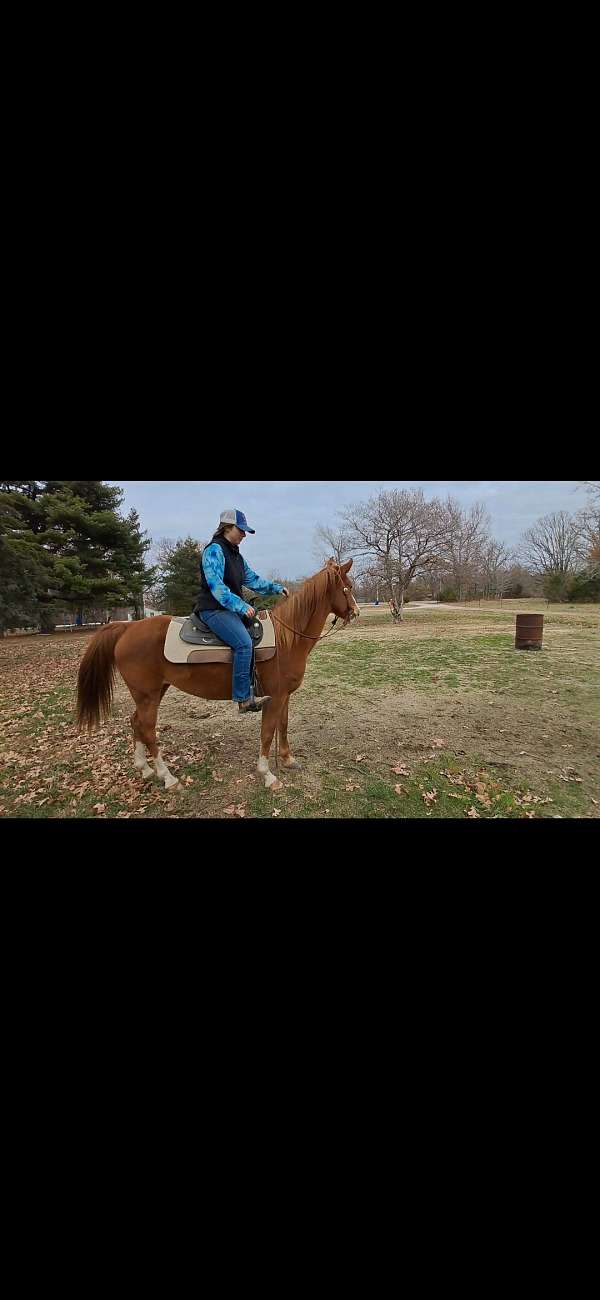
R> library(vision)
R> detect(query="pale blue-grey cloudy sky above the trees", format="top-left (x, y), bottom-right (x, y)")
top-left (110, 478), bottom-right (586, 579)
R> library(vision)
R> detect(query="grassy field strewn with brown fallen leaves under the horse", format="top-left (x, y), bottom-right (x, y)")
top-left (0, 601), bottom-right (600, 820)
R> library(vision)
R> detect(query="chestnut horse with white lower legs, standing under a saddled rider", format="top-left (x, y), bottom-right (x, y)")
top-left (77, 560), bottom-right (360, 790)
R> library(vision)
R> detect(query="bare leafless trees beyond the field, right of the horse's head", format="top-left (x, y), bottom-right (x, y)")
top-left (314, 482), bottom-right (600, 618)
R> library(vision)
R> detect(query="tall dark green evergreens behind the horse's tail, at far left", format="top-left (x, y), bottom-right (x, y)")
top-left (0, 478), bottom-right (156, 632)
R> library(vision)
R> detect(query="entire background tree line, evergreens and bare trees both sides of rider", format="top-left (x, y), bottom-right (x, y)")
top-left (0, 480), bottom-right (600, 631)
